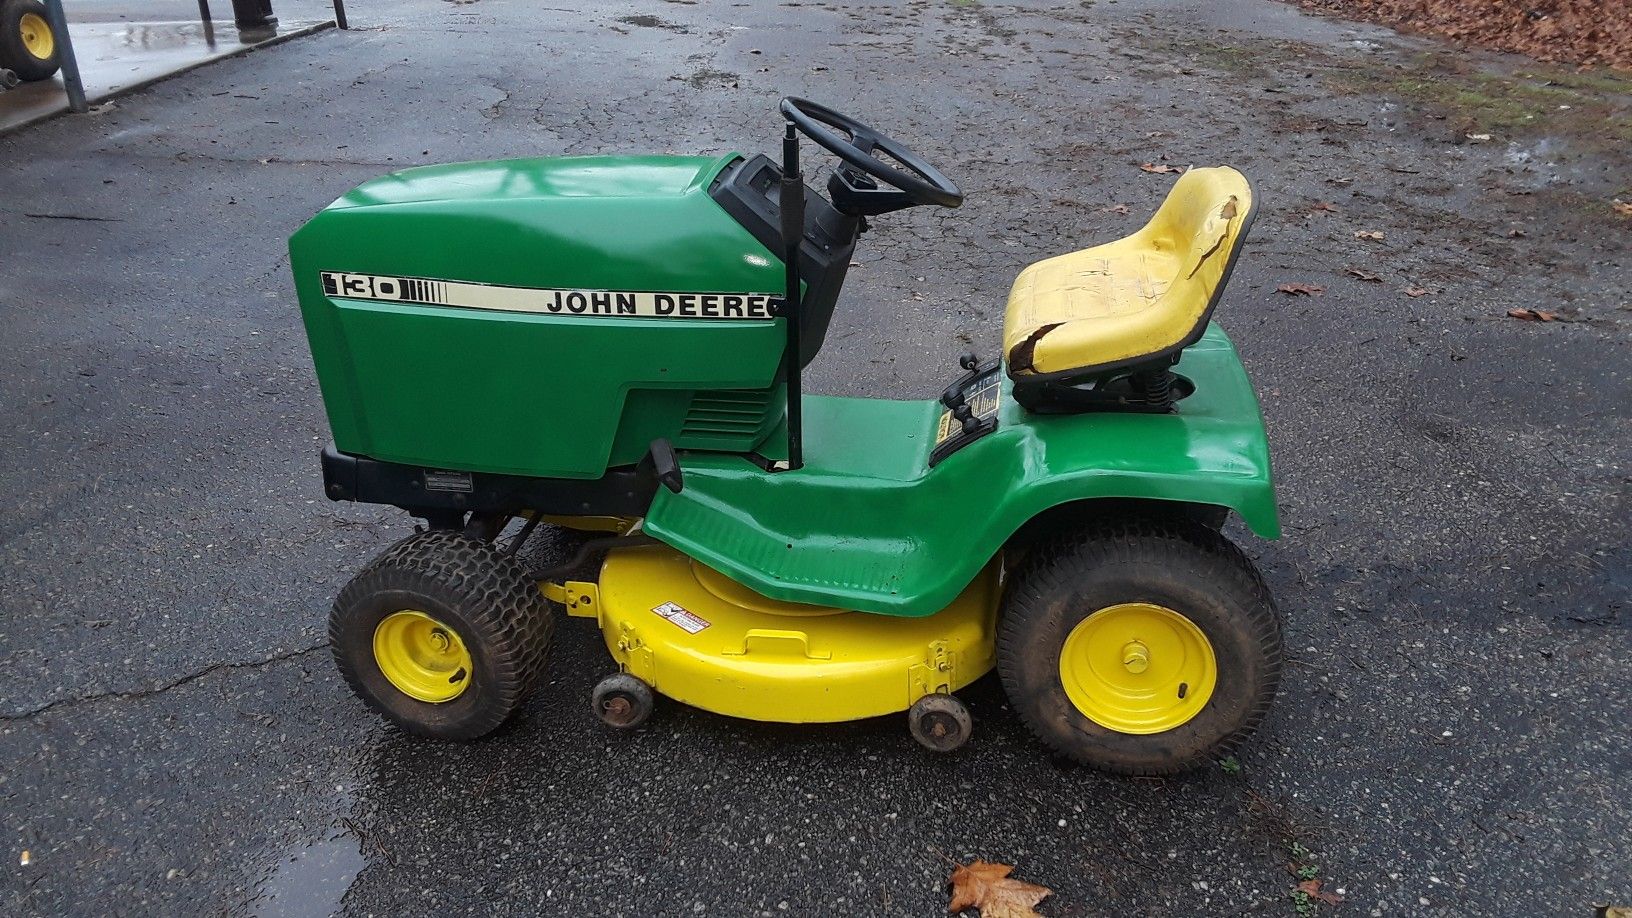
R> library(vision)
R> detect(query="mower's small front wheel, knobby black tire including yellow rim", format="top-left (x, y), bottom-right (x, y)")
top-left (328, 529), bottom-right (553, 740)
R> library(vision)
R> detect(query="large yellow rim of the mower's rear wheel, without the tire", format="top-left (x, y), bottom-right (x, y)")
top-left (1059, 603), bottom-right (1217, 735)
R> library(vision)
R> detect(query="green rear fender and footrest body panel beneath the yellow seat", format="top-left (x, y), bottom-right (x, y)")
top-left (645, 327), bottom-right (1279, 616)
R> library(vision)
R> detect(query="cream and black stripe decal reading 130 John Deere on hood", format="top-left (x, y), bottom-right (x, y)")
top-left (320, 271), bottom-right (778, 319)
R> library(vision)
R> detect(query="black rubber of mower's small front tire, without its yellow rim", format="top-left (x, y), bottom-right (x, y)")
top-left (328, 529), bottom-right (555, 740)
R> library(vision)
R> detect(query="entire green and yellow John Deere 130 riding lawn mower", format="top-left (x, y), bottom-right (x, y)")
top-left (290, 98), bottom-right (1281, 774)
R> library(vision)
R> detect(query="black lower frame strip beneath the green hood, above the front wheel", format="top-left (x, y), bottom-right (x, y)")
top-left (323, 443), bottom-right (658, 516)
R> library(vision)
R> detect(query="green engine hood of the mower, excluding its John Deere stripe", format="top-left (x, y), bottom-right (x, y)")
top-left (289, 154), bottom-right (783, 479)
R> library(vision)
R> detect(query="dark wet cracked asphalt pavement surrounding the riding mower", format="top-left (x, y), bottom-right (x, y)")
top-left (0, 0), bottom-right (1632, 916)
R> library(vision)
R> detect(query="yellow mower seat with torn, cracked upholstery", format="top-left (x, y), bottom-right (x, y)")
top-left (1004, 167), bottom-right (1252, 384)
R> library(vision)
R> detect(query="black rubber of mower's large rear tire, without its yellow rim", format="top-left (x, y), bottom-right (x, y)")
top-left (997, 519), bottom-right (1281, 776)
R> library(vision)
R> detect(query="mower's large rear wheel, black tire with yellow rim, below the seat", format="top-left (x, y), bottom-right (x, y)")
top-left (997, 521), bottom-right (1281, 776)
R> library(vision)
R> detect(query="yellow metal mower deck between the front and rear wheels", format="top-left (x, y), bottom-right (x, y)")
top-left (543, 546), bottom-right (1002, 724)
